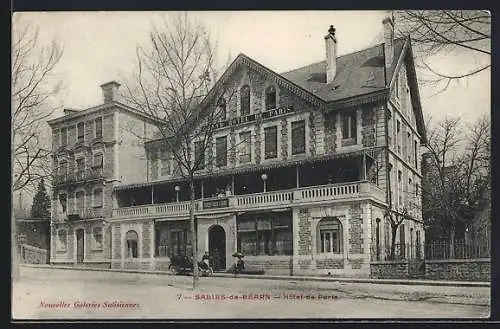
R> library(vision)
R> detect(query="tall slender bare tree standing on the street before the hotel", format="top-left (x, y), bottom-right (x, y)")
top-left (123, 14), bottom-right (234, 289)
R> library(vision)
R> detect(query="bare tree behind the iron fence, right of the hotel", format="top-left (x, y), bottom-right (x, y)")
top-left (421, 117), bottom-right (491, 257)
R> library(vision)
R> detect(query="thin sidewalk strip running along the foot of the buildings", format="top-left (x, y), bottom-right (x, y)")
top-left (20, 264), bottom-right (491, 287)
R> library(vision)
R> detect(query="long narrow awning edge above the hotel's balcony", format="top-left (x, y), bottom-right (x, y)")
top-left (115, 146), bottom-right (383, 191)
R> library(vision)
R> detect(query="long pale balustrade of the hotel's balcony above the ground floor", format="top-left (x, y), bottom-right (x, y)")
top-left (113, 181), bottom-right (385, 218)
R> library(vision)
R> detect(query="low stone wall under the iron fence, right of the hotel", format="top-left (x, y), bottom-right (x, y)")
top-left (425, 258), bottom-right (491, 281)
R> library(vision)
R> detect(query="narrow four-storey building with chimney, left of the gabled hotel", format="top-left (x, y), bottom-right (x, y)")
top-left (48, 82), bottom-right (158, 266)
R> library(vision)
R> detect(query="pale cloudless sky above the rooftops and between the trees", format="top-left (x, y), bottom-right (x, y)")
top-left (13, 11), bottom-right (491, 201)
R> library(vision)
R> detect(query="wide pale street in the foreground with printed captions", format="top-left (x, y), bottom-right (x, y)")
top-left (12, 267), bottom-right (490, 320)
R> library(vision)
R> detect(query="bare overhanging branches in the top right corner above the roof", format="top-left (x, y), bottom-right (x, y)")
top-left (394, 10), bottom-right (491, 90)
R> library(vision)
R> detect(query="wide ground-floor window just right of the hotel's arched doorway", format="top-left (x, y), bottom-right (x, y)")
top-left (237, 214), bottom-right (293, 255)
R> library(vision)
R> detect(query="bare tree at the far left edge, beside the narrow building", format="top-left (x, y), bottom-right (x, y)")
top-left (11, 17), bottom-right (63, 191)
